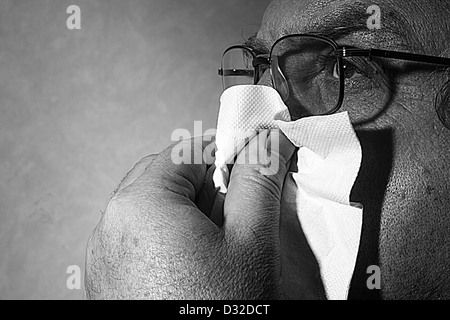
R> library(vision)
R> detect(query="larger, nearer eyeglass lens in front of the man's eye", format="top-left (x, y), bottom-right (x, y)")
top-left (271, 36), bottom-right (341, 116)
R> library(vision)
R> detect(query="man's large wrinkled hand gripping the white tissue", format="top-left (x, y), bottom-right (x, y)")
top-left (86, 131), bottom-right (295, 299)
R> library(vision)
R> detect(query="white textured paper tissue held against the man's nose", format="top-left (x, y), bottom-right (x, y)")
top-left (213, 85), bottom-right (362, 300)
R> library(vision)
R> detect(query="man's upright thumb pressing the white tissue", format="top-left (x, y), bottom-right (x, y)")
top-left (224, 130), bottom-right (295, 237)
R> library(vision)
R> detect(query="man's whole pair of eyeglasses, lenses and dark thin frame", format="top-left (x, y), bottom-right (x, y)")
top-left (219, 34), bottom-right (450, 117)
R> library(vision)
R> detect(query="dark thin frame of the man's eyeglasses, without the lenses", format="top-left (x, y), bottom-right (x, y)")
top-left (218, 33), bottom-right (450, 116)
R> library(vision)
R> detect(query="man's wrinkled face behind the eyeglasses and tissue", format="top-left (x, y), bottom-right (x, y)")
top-left (257, 0), bottom-right (450, 298)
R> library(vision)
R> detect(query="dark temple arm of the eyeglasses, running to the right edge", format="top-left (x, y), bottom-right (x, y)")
top-left (337, 47), bottom-right (450, 66)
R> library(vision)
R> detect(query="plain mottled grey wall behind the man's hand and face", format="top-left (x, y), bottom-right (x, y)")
top-left (0, 0), bottom-right (269, 299)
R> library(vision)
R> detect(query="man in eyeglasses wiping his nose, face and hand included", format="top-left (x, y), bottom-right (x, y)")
top-left (86, 0), bottom-right (450, 299)
